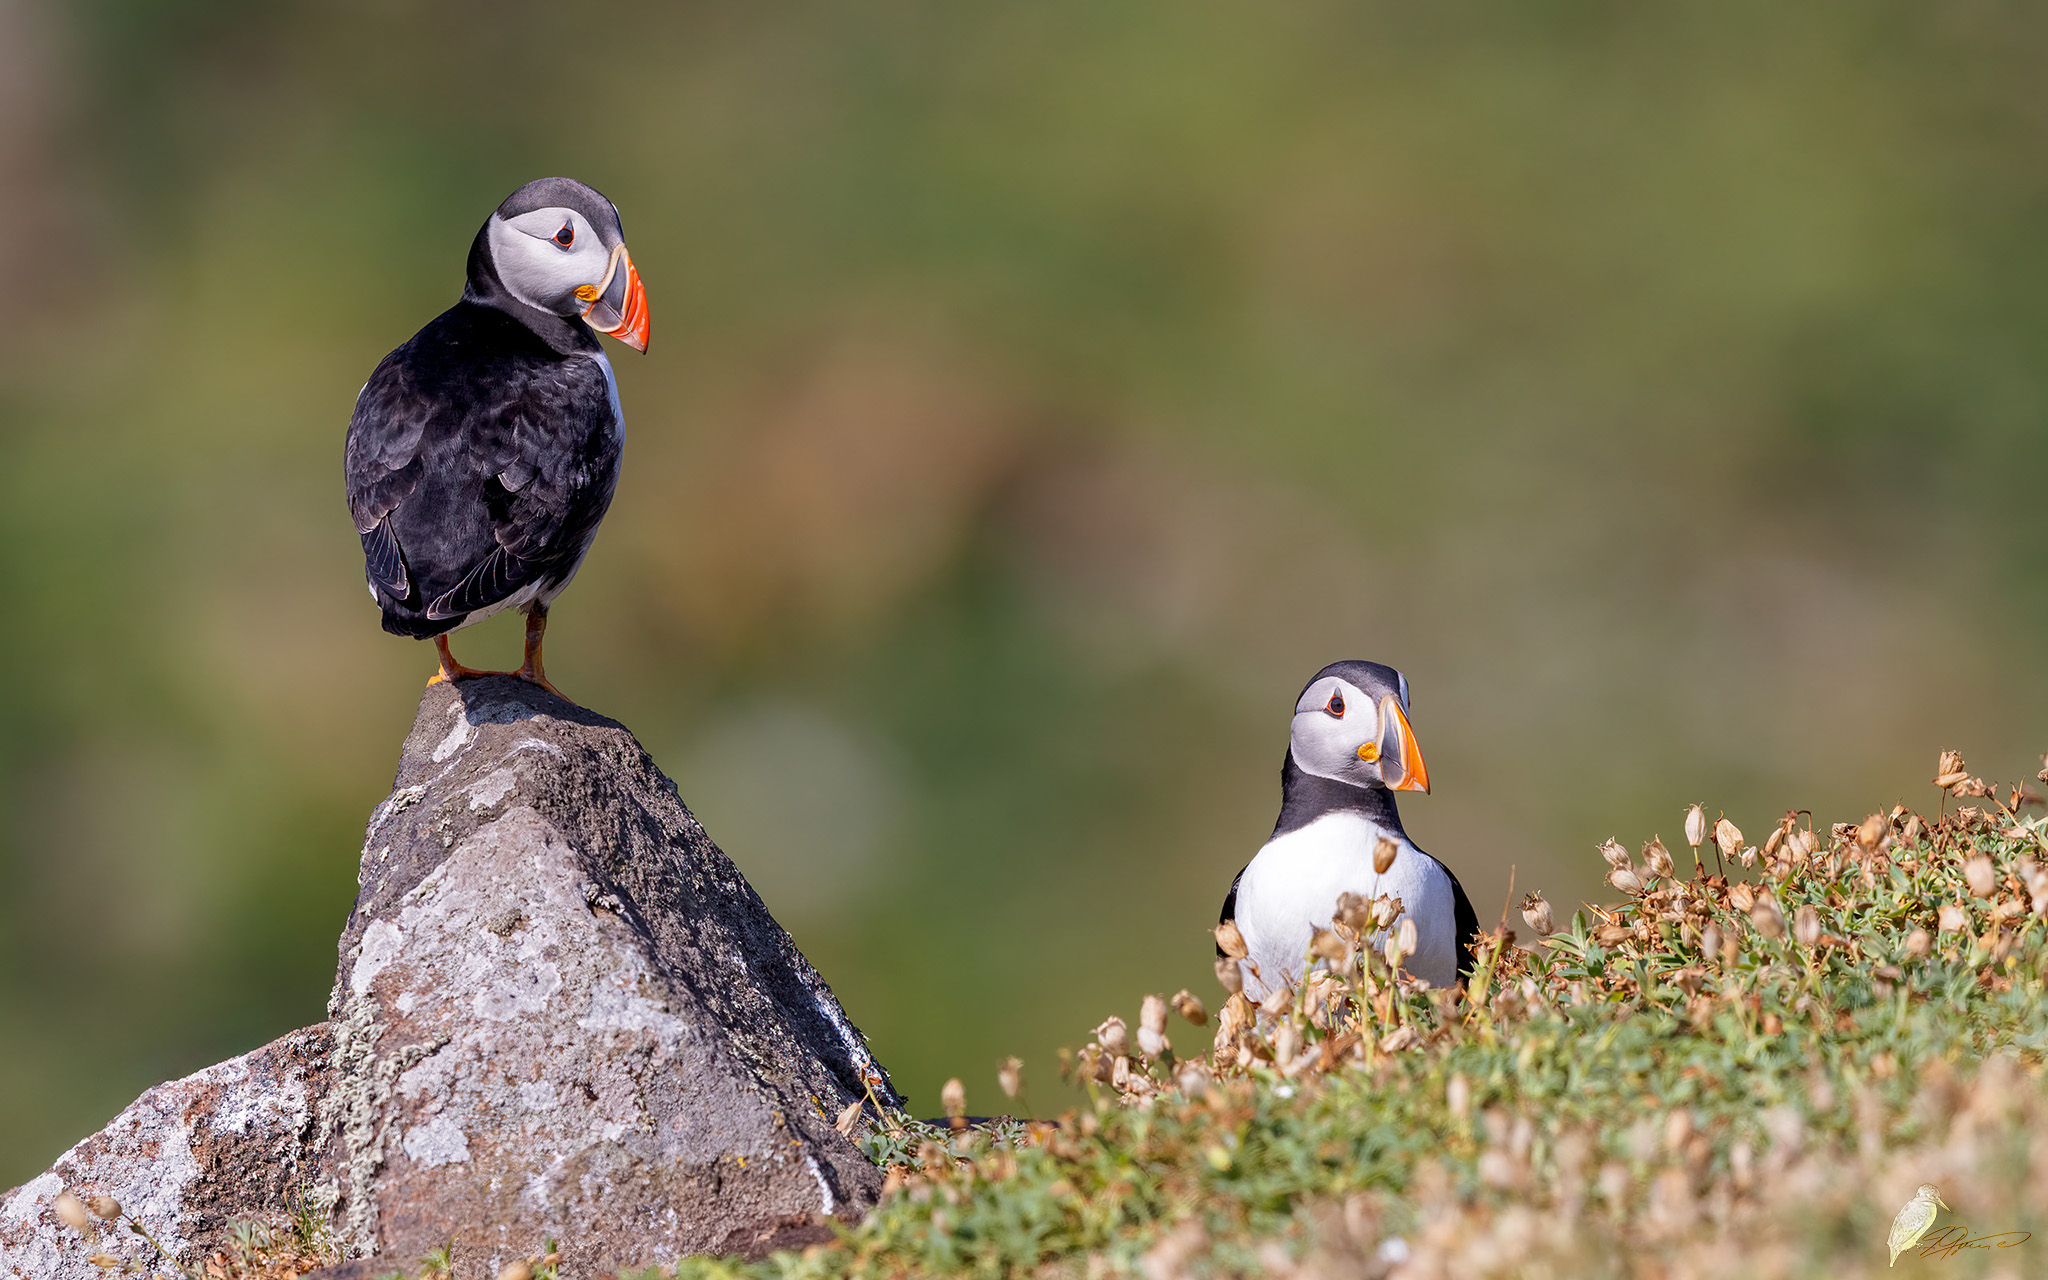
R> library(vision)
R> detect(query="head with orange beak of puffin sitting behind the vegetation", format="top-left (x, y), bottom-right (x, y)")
top-left (1288, 662), bottom-right (1430, 791)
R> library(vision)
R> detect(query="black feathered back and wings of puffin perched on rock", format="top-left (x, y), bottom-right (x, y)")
top-left (344, 303), bottom-right (618, 635)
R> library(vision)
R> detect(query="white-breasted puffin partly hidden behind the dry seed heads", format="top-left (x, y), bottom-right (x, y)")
top-left (1217, 662), bottom-right (1479, 999)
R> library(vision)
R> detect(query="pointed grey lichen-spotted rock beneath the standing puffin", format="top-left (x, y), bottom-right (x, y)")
top-left (0, 678), bottom-right (897, 1280)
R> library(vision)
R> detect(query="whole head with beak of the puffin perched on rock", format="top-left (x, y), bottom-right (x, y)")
top-left (469, 178), bottom-right (647, 352)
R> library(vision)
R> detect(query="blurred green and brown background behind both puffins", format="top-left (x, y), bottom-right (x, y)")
top-left (0, 0), bottom-right (2048, 1186)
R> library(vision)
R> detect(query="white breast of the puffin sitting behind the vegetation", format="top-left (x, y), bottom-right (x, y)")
top-left (1237, 813), bottom-right (1458, 999)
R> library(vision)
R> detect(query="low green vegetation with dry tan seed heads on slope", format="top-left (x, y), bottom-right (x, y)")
top-left (659, 754), bottom-right (2048, 1280)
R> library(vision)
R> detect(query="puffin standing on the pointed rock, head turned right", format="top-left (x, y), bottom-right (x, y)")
top-left (344, 178), bottom-right (647, 692)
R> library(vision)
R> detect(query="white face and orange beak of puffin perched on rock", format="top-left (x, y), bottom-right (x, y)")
top-left (489, 209), bottom-right (647, 350)
